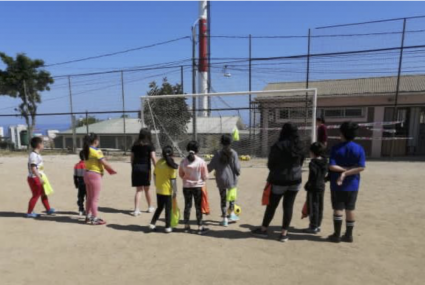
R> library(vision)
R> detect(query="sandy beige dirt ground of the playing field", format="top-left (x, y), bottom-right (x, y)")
top-left (0, 156), bottom-right (425, 285)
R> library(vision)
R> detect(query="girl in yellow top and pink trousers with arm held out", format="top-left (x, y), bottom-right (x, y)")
top-left (83, 133), bottom-right (116, 225)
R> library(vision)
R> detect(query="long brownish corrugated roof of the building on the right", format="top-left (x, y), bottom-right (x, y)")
top-left (264, 75), bottom-right (425, 96)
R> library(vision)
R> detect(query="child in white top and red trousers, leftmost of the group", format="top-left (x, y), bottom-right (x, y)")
top-left (26, 137), bottom-right (55, 218)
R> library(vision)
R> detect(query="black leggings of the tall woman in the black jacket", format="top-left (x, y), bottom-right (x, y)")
top-left (263, 190), bottom-right (298, 230)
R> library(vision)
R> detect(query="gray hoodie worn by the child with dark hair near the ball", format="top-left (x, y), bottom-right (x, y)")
top-left (208, 149), bottom-right (241, 189)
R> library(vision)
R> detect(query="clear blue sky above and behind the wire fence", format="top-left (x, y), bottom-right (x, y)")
top-left (0, 1), bottom-right (425, 130)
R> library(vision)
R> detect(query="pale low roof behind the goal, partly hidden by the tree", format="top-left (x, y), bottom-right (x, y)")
top-left (60, 116), bottom-right (243, 135)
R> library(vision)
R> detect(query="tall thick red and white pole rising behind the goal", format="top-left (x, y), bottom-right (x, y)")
top-left (198, 1), bottom-right (209, 117)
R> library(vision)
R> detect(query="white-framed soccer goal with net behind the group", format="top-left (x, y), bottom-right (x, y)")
top-left (141, 88), bottom-right (317, 160)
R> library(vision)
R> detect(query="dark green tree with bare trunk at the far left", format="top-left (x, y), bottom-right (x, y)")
top-left (0, 53), bottom-right (54, 143)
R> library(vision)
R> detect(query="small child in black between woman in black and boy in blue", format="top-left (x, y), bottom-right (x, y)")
top-left (304, 142), bottom-right (328, 234)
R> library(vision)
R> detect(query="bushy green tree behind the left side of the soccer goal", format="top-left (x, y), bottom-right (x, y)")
top-left (143, 78), bottom-right (192, 149)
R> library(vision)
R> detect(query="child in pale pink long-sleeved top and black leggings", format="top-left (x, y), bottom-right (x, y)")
top-left (179, 141), bottom-right (209, 235)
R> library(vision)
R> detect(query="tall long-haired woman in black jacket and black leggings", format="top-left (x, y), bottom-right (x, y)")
top-left (252, 123), bottom-right (304, 242)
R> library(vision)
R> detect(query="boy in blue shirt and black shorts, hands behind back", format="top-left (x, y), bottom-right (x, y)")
top-left (328, 122), bottom-right (366, 243)
